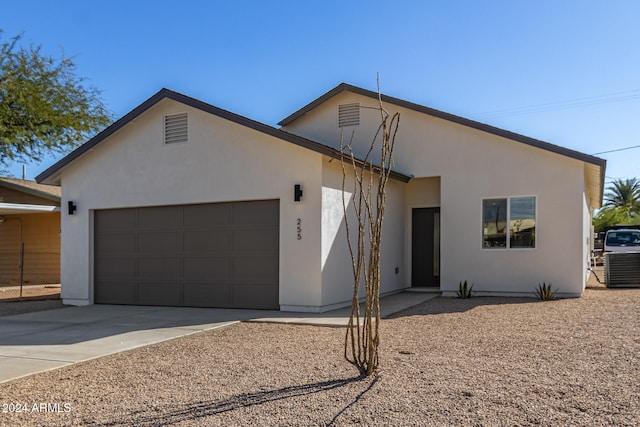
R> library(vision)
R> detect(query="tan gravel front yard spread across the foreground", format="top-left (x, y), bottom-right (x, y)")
top-left (0, 276), bottom-right (640, 426)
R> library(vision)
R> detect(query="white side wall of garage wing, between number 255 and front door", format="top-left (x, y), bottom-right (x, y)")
top-left (322, 159), bottom-right (406, 310)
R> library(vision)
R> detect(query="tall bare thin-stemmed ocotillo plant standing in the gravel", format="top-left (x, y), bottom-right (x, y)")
top-left (340, 78), bottom-right (400, 376)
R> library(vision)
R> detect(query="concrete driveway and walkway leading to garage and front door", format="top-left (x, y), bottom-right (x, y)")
top-left (0, 292), bottom-right (439, 383)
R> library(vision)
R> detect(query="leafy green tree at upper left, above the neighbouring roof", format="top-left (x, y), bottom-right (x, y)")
top-left (0, 30), bottom-right (112, 166)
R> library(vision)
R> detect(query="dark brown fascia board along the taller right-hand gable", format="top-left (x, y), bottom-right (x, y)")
top-left (278, 83), bottom-right (606, 168)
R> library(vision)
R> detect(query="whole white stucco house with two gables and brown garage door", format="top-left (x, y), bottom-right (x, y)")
top-left (37, 84), bottom-right (605, 312)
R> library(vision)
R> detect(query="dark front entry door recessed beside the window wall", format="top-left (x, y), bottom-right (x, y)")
top-left (411, 208), bottom-right (440, 287)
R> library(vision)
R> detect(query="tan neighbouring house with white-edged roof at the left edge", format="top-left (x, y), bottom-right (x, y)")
top-left (0, 177), bottom-right (60, 286)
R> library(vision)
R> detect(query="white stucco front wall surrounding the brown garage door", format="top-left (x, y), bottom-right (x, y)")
top-left (61, 99), bottom-right (322, 309)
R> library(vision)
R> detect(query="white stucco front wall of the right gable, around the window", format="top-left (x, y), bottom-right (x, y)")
top-left (285, 92), bottom-right (587, 296)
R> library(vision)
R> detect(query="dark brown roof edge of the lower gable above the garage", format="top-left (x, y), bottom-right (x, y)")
top-left (36, 88), bottom-right (411, 183)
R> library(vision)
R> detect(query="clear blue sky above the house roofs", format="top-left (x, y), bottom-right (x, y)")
top-left (0, 0), bottom-right (640, 181)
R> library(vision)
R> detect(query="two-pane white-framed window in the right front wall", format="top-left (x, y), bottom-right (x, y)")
top-left (482, 196), bottom-right (536, 249)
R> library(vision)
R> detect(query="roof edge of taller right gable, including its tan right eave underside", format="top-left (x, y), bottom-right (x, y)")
top-left (278, 83), bottom-right (607, 207)
